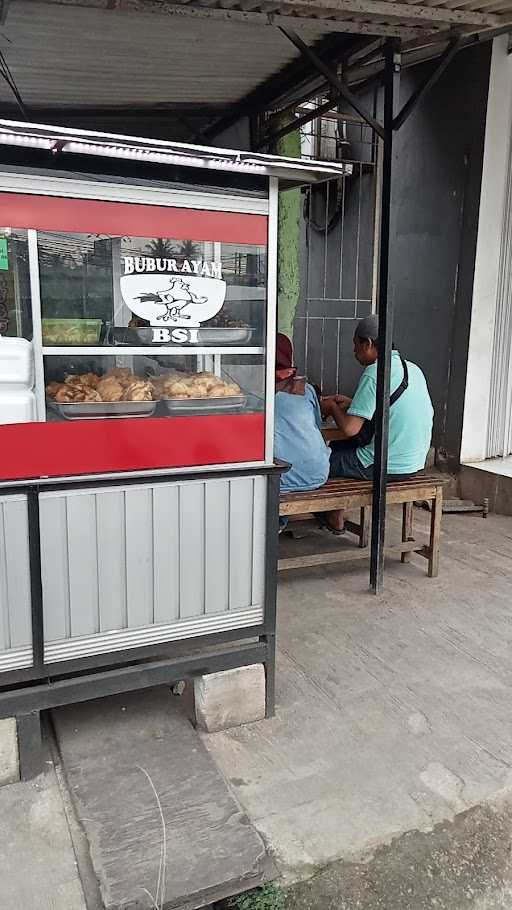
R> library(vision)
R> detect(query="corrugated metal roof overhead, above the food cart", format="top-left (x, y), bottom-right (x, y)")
top-left (0, 0), bottom-right (512, 128)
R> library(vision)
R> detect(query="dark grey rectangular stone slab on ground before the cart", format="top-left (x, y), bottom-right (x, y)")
top-left (53, 688), bottom-right (275, 910)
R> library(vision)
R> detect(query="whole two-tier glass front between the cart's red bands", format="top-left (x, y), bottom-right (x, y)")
top-left (38, 232), bottom-right (267, 421)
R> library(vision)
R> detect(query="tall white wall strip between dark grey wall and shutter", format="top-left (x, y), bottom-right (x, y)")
top-left (460, 35), bottom-right (512, 463)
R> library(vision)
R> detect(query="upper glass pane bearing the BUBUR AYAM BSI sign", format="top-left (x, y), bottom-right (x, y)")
top-left (38, 232), bottom-right (267, 346)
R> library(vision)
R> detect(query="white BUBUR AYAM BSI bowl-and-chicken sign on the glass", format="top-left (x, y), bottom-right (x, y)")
top-left (121, 256), bottom-right (226, 344)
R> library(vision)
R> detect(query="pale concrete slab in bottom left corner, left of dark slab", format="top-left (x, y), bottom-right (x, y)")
top-left (0, 764), bottom-right (86, 910)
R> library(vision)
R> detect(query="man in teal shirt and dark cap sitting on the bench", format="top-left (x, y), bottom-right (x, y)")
top-left (322, 316), bottom-right (434, 524)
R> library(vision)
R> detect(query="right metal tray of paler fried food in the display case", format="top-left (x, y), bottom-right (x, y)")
top-left (155, 373), bottom-right (247, 413)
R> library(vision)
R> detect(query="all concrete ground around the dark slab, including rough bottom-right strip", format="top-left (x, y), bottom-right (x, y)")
top-left (4, 512), bottom-right (512, 910)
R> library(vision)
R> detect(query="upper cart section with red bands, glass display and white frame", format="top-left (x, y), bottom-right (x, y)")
top-left (0, 178), bottom-right (274, 479)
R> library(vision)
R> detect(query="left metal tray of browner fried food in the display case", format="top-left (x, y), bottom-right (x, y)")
top-left (46, 367), bottom-right (156, 420)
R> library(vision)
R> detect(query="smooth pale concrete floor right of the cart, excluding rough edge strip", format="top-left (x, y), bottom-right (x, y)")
top-left (204, 510), bottom-right (512, 892)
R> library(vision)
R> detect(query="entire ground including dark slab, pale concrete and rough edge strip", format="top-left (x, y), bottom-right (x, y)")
top-left (0, 513), bottom-right (512, 910)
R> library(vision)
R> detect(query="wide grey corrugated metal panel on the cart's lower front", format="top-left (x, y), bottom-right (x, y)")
top-left (40, 477), bottom-right (266, 642)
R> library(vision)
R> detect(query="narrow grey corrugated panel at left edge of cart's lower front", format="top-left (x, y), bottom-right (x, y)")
top-left (0, 496), bottom-right (32, 669)
